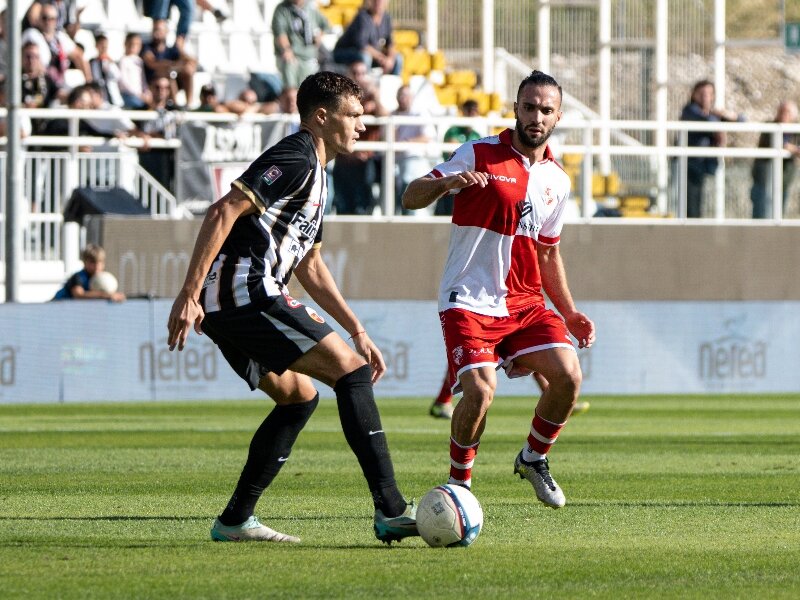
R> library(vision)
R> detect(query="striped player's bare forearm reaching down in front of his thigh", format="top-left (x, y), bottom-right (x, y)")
top-left (294, 247), bottom-right (386, 383)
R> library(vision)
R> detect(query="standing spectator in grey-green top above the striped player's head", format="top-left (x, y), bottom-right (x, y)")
top-left (272, 0), bottom-right (331, 88)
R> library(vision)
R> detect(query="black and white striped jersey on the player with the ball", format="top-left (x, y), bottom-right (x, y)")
top-left (200, 131), bottom-right (328, 312)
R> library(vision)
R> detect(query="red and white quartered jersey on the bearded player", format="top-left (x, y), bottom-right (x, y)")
top-left (430, 129), bottom-right (570, 317)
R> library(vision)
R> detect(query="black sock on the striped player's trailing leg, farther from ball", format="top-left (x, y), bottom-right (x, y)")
top-left (219, 394), bottom-right (319, 525)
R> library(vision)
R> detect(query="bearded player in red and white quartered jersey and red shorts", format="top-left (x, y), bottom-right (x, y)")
top-left (403, 71), bottom-right (595, 508)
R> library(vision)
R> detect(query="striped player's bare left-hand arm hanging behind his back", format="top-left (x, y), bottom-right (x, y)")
top-left (167, 188), bottom-right (256, 350)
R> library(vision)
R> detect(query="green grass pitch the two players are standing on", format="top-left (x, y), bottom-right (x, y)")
top-left (0, 396), bottom-right (800, 599)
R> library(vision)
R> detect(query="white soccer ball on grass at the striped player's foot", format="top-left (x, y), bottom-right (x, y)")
top-left (417, 484), bottom-right (483, 548)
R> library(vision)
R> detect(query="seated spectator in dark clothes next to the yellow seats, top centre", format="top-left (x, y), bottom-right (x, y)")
top-left (333, 0), bottom-right (403, 75)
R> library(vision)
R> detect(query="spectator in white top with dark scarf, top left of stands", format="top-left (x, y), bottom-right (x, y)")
top-left (21, 4), bottom-right (92, 86)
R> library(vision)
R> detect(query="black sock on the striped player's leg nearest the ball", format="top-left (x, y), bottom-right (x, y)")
top-left (333, 365), bottom-right (406, 517)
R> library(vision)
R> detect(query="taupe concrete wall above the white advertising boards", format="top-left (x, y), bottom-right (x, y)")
top-left (95, 216), bottom-right (800, 301)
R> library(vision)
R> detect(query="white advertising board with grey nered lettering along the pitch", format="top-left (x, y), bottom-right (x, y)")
top-left (0, 300), bottom-right (800, 404)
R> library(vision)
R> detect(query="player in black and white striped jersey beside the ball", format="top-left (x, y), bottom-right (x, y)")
top-left (167, 72), bottom-right (418, 543)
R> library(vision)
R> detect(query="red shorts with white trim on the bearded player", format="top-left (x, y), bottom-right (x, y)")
top-left (439, 306), bottom-right (575, 390)
